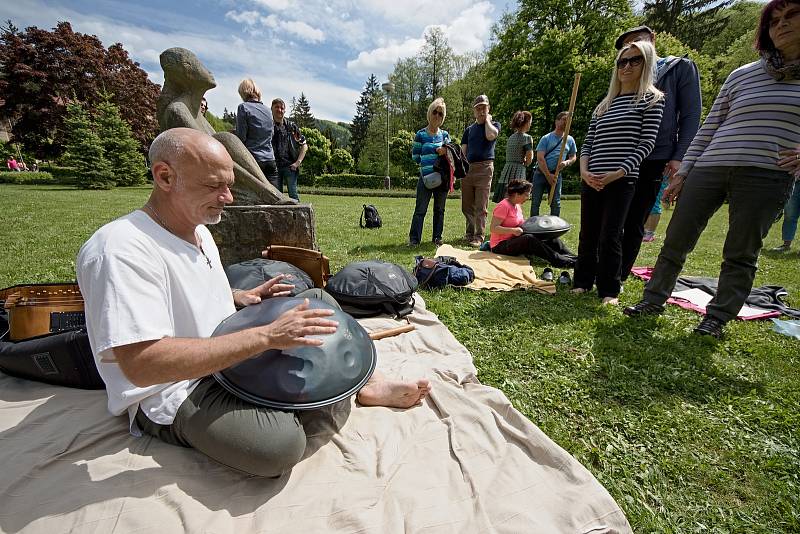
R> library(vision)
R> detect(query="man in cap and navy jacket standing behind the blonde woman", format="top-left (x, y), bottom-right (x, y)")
top-left (615, 26), bottom-right (702, 281)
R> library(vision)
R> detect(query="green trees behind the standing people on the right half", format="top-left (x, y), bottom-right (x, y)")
top-left (350, 0), bottom-right (763, 180)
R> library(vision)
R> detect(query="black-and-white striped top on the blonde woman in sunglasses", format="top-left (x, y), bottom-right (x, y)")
top-left (581, 94), bottom-right (664, 180)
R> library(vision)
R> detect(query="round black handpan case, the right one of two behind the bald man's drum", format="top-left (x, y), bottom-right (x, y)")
top-left (325, 260), bottom-right (417, 319)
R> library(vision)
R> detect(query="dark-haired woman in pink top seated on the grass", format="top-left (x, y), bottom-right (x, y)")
top-left (489, 180), bottom-right (536, 256)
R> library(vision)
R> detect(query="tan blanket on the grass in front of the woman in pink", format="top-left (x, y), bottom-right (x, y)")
top-left (436, 245), bottom-right (556, 295)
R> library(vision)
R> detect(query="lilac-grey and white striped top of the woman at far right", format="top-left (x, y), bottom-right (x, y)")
top-left (680, 61), bottom-right (800, 176)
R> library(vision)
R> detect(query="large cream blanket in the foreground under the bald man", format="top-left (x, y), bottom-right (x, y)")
top-left (0, 298), bottom-right (630, 534)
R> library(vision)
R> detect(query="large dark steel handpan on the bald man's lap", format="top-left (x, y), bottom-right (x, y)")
top-left (212, 298), bottom-right (376, 410)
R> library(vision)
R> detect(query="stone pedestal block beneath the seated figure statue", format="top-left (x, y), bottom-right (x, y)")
top-left (208, 204), bottom-right (317, 266)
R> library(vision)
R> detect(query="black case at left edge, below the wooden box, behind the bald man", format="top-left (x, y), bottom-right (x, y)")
top-left (0, 328), bottom-right (105, 389)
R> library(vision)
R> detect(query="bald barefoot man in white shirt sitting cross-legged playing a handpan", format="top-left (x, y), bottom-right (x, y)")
top-left (76, 128), bottom-right (430, 477)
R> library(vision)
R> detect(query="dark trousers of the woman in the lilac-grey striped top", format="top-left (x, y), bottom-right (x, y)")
top-left (644, 167), bottom-right (792, 321)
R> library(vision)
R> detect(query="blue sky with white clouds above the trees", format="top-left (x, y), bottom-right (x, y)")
top-left (0, 0), bottom-right (515, 122)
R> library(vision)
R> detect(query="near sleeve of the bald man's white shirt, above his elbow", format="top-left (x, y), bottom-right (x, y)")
top-left (80, 253), bottom-right (175, 354)
